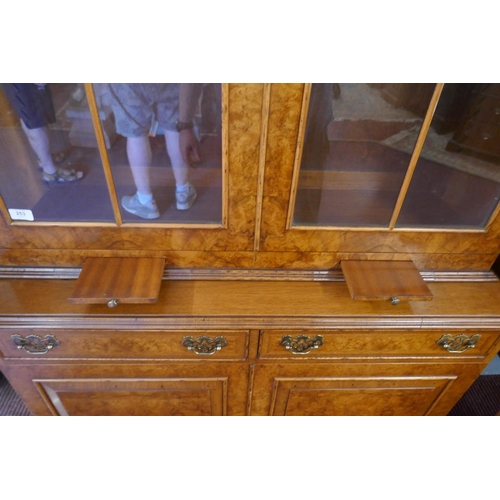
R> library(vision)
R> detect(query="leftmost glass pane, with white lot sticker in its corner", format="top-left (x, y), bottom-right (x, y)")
top-left (0, 83), bottom-right (115, 222)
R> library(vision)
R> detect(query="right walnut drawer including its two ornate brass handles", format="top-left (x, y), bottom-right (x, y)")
top-left (259, 330), bottom-right (499, 360)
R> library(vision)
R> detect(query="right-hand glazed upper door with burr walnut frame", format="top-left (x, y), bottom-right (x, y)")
top-left (258, 83), bottom-right (500, 269)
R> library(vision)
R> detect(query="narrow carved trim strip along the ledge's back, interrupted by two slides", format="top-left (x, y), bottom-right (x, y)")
top-left (0, 266), bottom-right (498, 283)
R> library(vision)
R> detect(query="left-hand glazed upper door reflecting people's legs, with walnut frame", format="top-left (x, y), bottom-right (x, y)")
top-left (0, 83), bottom-right (264, 267)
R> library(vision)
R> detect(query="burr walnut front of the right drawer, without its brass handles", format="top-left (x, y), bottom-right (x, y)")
top-left (259, 330), bottom-right (500, 363)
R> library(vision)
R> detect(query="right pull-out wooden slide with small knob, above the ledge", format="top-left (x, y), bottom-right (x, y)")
top-left (340, 260), bottom-right (432, 304)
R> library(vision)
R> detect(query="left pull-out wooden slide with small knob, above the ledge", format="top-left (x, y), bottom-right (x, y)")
top-left (68, 257), bottom-right (165, 307)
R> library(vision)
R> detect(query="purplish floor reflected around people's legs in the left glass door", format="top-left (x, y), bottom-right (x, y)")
top-left (0, 127), bottom-right (222, 224)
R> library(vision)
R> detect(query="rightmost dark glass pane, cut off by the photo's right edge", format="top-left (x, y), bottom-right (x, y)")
top-left (397, 83), bottom-right (500, 228)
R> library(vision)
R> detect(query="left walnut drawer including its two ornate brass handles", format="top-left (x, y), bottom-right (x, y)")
top-left (0, 329), bottom-right (248, 360)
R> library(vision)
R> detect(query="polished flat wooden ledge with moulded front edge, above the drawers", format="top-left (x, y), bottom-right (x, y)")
top-left (0, 279), bottom-right (500, 329)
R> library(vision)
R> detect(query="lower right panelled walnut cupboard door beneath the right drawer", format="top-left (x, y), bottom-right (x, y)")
top-left (251, 363), bottom-right (480, 416)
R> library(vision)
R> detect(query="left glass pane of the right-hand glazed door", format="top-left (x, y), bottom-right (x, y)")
top-left (293, 83), bottom-right (435, 227)
